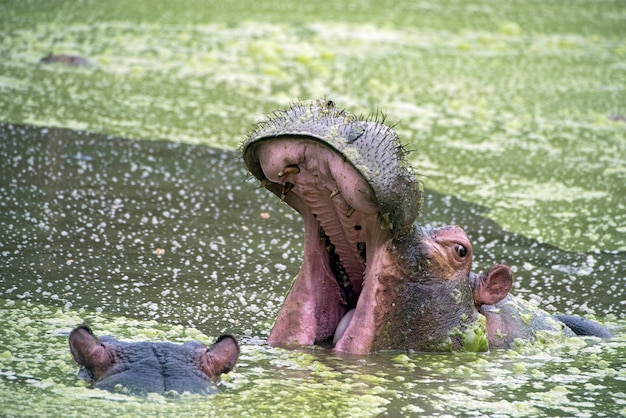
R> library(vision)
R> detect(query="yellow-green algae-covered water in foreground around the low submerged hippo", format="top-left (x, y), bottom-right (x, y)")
top-left (0, 299), bottom-right (626, 417)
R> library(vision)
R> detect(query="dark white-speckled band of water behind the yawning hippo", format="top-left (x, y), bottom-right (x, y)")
top-left (0, 120), bottom-right (626, 324)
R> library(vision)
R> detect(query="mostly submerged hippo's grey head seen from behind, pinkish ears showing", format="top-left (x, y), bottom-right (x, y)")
top-left (69, 324), bottom-right (239, 396)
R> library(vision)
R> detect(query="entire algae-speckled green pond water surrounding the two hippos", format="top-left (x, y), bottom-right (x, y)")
top-left (0, 0), bottom-right (626, 416)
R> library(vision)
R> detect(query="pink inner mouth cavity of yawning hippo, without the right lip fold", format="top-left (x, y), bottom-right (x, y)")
top-left (249, 138), bottom-right (389, 344)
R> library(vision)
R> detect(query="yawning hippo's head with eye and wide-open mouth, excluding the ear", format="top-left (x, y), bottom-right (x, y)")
top-left (242, 100), bottom-right (487, 354)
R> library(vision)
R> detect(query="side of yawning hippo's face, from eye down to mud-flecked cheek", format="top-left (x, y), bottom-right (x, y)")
top-left (381, 226), bottom-right (489, 352)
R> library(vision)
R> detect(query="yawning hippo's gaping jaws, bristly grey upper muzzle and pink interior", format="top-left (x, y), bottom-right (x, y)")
top-left (243, 102), bottom-right (420, 353)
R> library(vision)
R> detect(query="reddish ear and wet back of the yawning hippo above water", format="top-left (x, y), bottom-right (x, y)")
top-left (469, 264), bottom-right (612, 348)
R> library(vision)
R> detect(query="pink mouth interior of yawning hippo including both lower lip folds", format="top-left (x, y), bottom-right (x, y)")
top-left (255, 137), bottom-right (401, 353)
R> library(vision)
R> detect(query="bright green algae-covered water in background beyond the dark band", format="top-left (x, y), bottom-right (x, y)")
top-left (0, 0), bottom-right (626, 251)
